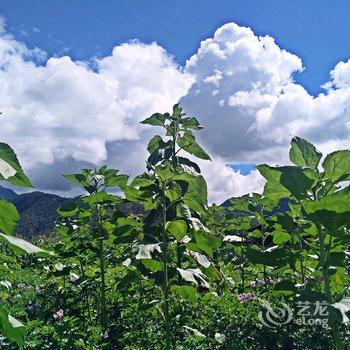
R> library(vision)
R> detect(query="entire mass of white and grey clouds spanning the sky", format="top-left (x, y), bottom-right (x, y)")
top-left (0, 23), bottom-right (350, 203)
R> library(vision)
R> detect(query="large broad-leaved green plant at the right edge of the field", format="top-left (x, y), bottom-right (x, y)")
top-left (258, 137), bottom-right (350, 349)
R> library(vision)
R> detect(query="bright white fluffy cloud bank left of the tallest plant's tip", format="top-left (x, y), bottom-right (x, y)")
top-left (0, 24), bottom-right (191, 168)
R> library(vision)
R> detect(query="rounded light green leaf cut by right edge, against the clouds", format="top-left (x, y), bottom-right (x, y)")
top-left (322, 150), bottom-right (350, 183)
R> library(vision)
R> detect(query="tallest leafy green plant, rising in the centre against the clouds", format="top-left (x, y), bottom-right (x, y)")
top-left (125, 104), bottom-right (221, 349)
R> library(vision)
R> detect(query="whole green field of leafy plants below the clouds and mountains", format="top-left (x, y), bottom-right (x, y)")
top-left (0, 105), bottom-right (350, 350)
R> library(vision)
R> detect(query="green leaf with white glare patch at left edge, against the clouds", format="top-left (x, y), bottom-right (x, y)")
top-left (0, 143), bottom-right (32, 187)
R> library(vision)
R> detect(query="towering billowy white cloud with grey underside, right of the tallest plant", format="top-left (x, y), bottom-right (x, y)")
top-left (183, 23), bottom-right (350, 163)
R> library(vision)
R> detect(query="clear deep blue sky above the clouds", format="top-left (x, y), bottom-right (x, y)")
top-left (0, 0), bottom-right (350, 95)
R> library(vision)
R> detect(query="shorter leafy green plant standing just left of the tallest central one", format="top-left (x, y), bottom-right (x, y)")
top-left (58, 166), bottom-right (128, 331)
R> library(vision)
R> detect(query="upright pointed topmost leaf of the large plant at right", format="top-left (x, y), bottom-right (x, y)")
top-left (289, 136), bottom-right (322, 169)
